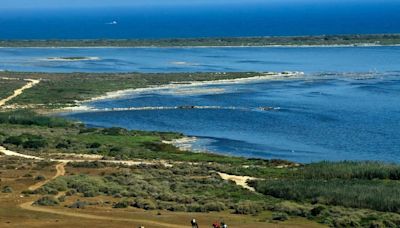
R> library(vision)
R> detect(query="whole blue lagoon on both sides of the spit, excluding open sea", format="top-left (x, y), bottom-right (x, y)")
top-left (0, 47), bottom-right (400, 162)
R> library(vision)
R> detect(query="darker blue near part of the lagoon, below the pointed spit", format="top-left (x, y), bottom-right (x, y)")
top-left (69, 72), bottom-right (400, 162)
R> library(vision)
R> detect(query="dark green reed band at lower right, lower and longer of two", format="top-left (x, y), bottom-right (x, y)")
top-left (254, 179), bottom-right (400, 213)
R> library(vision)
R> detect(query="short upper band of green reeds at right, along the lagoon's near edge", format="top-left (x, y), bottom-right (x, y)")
top-left (296, 161), bottom-right (400, 180)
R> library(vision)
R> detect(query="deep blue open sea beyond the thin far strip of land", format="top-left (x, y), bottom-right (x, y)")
top-left (0, 0), bottom-right (400, 39)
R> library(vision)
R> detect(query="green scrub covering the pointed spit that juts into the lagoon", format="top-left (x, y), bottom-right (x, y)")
top-left (0, 71), bottom-right (262, 109)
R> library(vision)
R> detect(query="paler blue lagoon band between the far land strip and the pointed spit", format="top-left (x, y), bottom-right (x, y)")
top-left (0, 47), bottom-right (400, 73)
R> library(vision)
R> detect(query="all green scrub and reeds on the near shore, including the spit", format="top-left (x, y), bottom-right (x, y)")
top-left (0, 72), bottom-right (400, 227)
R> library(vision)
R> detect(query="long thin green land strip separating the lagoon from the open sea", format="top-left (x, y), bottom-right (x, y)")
top-left (0, 34), bottom-right (400, 47)
